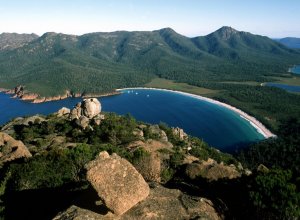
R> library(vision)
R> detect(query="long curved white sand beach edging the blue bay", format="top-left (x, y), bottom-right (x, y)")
top-left (116, 87), bottom-right (276, 138)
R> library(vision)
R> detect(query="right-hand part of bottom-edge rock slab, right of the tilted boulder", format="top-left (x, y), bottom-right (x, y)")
top-left (121, 185), bottom-right (221, 220)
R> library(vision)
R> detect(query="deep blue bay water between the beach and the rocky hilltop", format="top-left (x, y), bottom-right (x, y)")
top-left (0, 89), bottom-right (263, 151)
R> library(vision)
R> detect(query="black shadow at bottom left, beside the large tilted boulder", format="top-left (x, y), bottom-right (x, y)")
top-left (1, 184), bottom-right (108, 220)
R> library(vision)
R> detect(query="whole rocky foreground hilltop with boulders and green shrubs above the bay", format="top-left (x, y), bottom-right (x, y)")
top-left (0, 98), bottom-right (271, 220)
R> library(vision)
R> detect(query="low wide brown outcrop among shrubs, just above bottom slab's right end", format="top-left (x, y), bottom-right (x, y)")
top-left (185, 158), bottom-right (241, 181)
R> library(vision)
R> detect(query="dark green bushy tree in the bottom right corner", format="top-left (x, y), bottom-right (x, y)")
top-left (250, 169), bottom-right (300, 219)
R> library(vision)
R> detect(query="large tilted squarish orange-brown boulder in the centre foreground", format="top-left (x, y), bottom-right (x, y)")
top-left (86, 151), bottom-right (150, 215)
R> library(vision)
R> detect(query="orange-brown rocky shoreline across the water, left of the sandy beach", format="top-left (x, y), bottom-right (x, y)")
top-left (0, 85), bottom-right (120, 104)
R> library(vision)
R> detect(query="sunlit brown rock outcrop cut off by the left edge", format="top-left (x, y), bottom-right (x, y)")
top-left (0, 132), bottom-right (31, 164)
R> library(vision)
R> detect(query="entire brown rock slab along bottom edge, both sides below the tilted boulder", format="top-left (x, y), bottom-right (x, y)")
top-left (54, 185), bottom-right (223, 220)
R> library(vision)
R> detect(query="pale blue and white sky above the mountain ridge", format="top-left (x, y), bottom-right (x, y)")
top-left (0, 0), bottom-right (300, 38)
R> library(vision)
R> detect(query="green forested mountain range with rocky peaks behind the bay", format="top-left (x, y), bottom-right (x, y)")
top-left (0, 27), bottom-right (300, 96)
